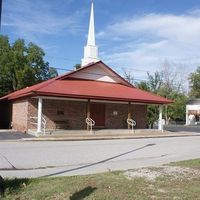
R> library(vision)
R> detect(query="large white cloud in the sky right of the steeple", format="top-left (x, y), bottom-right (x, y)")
top-left (98, 10), bottom-right (200, 77)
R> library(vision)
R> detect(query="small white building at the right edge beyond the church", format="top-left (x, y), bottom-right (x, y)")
top-left (186, 99), bottom-right (200, 125)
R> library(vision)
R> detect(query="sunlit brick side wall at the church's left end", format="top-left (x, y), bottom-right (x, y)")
top-left (12, 100), bottom-right (28, 132)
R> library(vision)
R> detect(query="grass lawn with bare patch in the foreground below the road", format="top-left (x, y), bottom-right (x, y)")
top-left (2, 159), bottom-right (200, 200)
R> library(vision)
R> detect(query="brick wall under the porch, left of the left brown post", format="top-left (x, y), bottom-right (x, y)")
top-left (28, 99), bottom-right (86, 129)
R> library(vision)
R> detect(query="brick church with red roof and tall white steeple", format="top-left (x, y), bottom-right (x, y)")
top-left (0, 4), bottom-right (171, 133)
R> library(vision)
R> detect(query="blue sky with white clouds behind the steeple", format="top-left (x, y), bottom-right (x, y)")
top-left (1, 0), bottom-right (200, 83)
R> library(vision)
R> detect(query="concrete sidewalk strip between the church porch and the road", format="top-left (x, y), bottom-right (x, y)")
top-left (0, 129), bottom-right (200, 142)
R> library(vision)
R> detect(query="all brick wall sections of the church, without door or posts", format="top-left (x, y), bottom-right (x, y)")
top-left (12, 98), bottom-right (147, 131)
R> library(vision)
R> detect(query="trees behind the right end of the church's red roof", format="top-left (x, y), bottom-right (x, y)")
top-left (124, 62), bottom-right (188, 127)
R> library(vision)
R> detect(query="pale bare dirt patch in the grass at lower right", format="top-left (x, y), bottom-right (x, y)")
top-left (124, 166), bottom-right (200, 181)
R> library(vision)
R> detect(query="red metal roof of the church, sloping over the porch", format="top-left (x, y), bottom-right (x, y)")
top-left (0, 61), bottom-right (172, 104)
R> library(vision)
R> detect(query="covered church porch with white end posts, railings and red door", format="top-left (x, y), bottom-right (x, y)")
top-left (28, 96), bottom-right (163, 135)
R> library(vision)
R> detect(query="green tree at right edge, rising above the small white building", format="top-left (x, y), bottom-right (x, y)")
top-left (189, 66), bottom-right (200, 98)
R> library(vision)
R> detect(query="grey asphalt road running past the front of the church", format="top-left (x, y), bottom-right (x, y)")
top-left (0, 136), bottom-right (200, 177)
